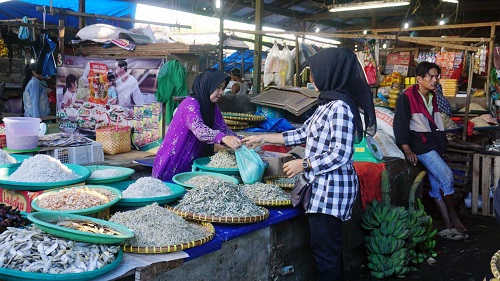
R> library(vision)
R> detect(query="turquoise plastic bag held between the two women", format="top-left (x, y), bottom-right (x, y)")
top-left (235, 145), bottom-right (266, 184)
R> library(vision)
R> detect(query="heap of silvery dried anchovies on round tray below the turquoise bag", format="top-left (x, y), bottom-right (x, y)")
top-left (175, 182), bottom-right (265, 217)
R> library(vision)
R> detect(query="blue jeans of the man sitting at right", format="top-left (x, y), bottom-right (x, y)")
top-left (417, 150), bottom-right (455, 199)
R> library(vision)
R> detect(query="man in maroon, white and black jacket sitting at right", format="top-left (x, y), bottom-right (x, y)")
top-left (394, 61), bottom-right (468, 240)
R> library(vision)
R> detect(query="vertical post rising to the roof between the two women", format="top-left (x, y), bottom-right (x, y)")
top-left (253, 0), bottom-right (264, 94)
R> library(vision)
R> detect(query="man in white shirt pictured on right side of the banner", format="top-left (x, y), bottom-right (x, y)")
top-left (115, 60), bottom-right (144, 109)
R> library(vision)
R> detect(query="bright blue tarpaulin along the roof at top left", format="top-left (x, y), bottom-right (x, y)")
top-left (0, 0), bottom-right (136, 29)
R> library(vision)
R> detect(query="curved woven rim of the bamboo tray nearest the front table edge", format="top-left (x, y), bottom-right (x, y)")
top-left (123, 221), bottom-right (215, 254)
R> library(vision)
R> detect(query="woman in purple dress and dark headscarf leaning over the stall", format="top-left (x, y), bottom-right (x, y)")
top-left (153, 68), bottom-right (241, 181)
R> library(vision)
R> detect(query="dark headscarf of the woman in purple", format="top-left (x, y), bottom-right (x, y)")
top-left (191, 68), bottom-right (231, 129)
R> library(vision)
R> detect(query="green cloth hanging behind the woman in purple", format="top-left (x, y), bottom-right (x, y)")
top-left (155, 60), bottom-right (187, 124)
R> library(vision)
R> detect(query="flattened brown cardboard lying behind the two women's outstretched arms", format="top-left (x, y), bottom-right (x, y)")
top-left (250, 86), bottom-right (319, 116)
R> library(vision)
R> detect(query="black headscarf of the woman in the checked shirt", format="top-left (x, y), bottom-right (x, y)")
top-left (307, 48), bottom-right (376, 143)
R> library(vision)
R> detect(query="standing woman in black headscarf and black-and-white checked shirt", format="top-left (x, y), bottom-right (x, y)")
top-left (243, 48), bottom-right (376, 280)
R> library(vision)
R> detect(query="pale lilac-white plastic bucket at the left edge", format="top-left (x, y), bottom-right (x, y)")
top-left (3, 117), bottom-right (42, 150)
